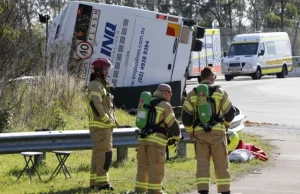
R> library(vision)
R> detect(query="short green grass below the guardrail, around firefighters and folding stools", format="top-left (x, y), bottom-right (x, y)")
top-left (0, 133), bottom-right (274, 194)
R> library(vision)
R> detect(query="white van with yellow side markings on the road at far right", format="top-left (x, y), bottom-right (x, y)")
top-left (222, 32), bottom-right (292, 81)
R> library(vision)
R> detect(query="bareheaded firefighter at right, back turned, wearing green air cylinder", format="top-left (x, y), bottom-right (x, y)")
top-left (182, 67), bottom-right (235, 194)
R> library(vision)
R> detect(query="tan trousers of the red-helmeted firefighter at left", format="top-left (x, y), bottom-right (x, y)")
top-left (90, 128), bottom-right (113, 186)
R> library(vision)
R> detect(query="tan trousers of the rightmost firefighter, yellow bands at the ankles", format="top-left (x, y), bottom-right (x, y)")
top-left (195, 130), bottom-right (230, 193)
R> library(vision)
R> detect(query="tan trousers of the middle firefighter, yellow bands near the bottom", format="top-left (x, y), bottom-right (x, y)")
top-left (135, 145), bottom-right (166, 194)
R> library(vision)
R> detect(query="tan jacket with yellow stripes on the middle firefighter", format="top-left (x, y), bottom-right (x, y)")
top-left (139, 91), bottom-right (181, 146)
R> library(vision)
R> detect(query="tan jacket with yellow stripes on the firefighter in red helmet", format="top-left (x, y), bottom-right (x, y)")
top-left (87, 77), bottom-right (116, 129)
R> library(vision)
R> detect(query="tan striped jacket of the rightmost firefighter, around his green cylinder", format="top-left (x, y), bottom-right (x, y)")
top-left (182, 80), bottom-right (235, 133)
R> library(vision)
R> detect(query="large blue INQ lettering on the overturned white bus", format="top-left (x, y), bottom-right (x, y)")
top-left (100, 22), bottom-right (117, 57)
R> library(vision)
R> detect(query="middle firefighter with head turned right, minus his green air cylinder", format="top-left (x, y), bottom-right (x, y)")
top-left (135, 84), bottom-right (182, 194)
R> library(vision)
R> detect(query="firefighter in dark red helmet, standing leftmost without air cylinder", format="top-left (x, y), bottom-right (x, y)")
top-left (87, 58), bottom-right (116, 190)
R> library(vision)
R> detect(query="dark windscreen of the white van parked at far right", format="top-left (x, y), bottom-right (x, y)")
top-left (227, 43), bottom-right (258, 56)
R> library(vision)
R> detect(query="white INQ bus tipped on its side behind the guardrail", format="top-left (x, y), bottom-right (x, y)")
top-left (48, 1), bottom-right (205, 109)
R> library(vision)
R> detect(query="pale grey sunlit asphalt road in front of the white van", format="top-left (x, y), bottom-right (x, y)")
top-left (187, 76), bottom-right (300, 127)
